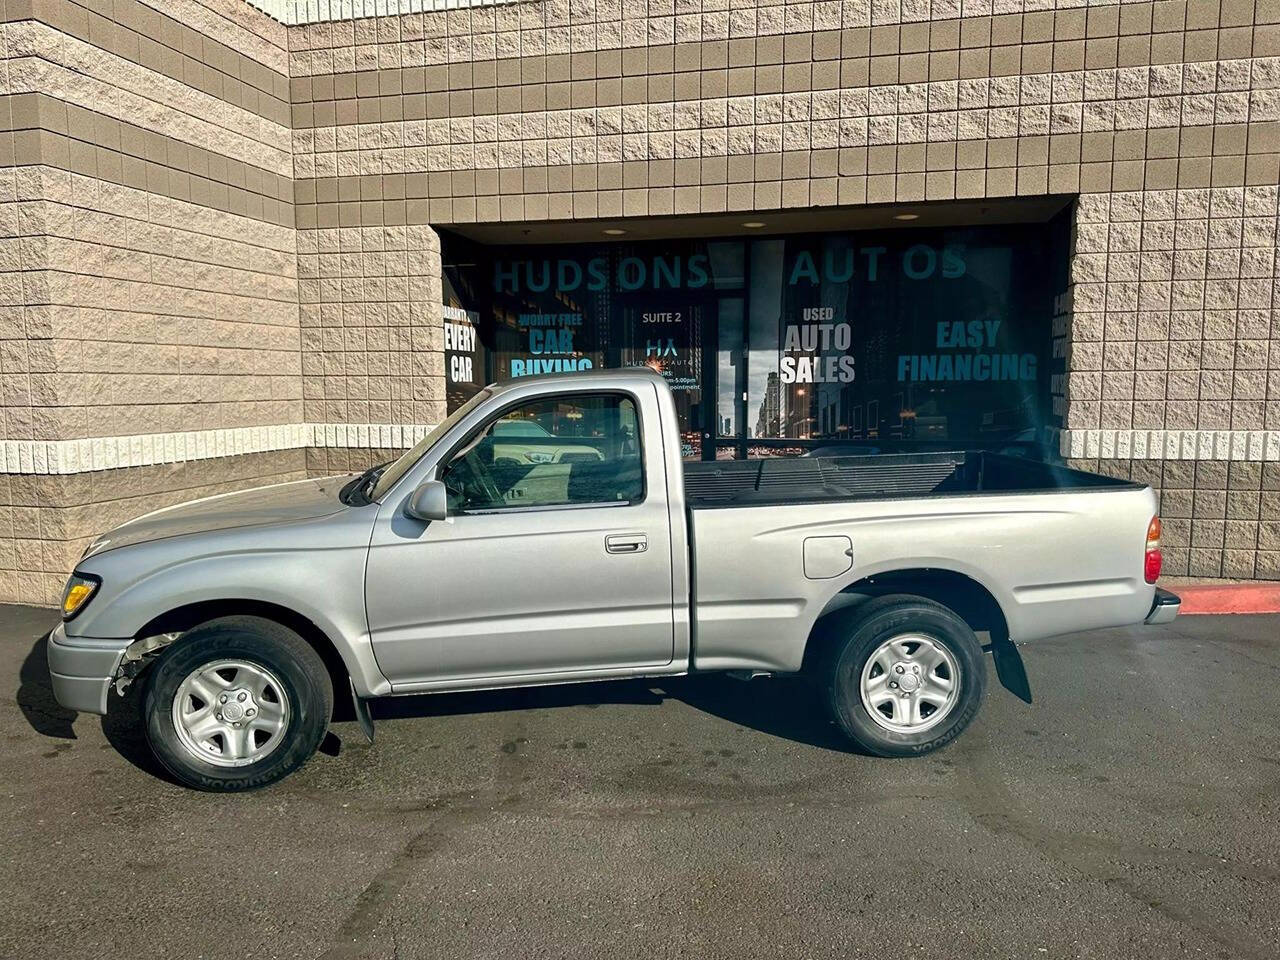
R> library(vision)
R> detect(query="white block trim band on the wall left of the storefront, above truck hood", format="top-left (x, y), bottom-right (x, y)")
top-left (0, 424), bottom-right (431, 476)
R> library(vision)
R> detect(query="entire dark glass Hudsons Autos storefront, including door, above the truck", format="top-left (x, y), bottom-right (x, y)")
top-left (445, 224), bottom-right (1052, 458)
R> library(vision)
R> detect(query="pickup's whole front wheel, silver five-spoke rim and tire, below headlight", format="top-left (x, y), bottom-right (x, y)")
top-left (143, 617), bottom-right (333, 792)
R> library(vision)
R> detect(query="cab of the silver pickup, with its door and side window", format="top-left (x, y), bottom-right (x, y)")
top-left (366, 372), bottom-right (689, 692)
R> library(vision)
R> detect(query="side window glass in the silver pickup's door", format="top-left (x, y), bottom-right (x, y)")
top-left (442, 394), bottom-right (644, 512)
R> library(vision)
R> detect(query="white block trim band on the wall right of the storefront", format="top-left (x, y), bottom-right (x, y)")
top-left (1060, 430), bottom-right (1280, 461)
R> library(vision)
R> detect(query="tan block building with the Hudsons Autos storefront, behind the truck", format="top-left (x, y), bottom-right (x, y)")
top-left (0, 0), bottom-right (1280, 603)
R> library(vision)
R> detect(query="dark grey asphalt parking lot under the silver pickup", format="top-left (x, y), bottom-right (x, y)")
top-left (0, 607), bottom-right (1280, 960)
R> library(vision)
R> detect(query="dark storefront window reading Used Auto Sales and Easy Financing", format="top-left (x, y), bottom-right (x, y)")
top-left (748, 230), bottom-right (1052, 442)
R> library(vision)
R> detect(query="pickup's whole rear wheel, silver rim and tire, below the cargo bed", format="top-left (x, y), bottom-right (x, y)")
top-left (826, 595), bottom-right (987, 756)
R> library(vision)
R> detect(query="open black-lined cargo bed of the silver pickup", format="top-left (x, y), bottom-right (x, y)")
top-left (684, 451), bottom-right (1140, 509)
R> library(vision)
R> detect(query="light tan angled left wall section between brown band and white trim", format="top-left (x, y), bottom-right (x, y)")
top-left (5, 165), bottom-right (302, 439)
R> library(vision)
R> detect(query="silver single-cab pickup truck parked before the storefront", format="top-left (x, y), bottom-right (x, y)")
top-left (49, 371), bottom-right (1179, 790)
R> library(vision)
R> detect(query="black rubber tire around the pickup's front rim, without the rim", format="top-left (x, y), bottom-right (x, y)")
top-left (142, 617), bottom-right (333, 792)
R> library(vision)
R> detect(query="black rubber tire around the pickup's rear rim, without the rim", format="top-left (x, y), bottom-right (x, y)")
top-left (822, 594), bottom-right (987, 756)
